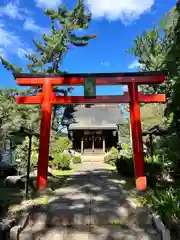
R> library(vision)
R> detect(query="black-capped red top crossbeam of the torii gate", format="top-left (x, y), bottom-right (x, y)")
top-left (14, 72), bottom-right (164, 86)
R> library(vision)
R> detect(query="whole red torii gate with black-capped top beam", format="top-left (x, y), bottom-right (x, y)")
top-left (15, 72), bottom-right (166, 191)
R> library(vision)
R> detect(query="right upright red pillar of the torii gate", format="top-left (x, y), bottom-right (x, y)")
top-left (128, 82), bottom-right (147, 190)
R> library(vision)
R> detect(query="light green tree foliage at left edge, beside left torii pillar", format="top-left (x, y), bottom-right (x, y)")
top-left (0, 89), bottom-right (40, 142)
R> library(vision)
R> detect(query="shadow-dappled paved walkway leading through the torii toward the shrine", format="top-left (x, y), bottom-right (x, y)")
top-left (20, 162), bottom-right (161, 240)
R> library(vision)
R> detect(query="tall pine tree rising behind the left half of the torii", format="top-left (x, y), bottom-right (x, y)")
top-left (0, 0), bottom-right (96, 130)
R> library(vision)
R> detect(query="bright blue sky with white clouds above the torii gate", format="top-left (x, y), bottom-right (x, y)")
top-left (0, 0), bottom-right (176, 95)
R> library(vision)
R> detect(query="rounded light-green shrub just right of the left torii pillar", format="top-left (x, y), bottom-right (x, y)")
top-left (52, 152), bottom-right (71, 170)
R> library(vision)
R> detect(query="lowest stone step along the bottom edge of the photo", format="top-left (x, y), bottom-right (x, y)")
top-left (19, 226), bottom-right (161, 240)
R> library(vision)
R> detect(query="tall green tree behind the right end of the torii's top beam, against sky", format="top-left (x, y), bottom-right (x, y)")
top-left (127, 8), bottom-right (177, 97)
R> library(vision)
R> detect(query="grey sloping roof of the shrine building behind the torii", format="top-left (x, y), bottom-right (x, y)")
top-left (63, 104), bottom-right (124, 130)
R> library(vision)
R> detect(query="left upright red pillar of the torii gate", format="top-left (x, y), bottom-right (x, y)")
top-left (37, 78), bottom-right (52, 191)
